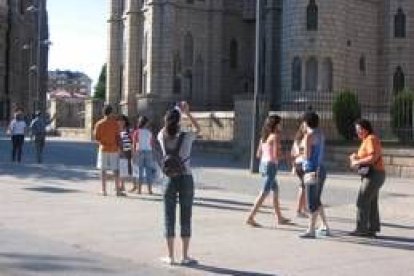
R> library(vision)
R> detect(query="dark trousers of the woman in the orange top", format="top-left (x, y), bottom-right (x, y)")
top-left (356, 170), bottom-right (385, 233)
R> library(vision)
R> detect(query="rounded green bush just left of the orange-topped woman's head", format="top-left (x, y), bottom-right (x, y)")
top-left (332, 89), bottom-right (361, 140)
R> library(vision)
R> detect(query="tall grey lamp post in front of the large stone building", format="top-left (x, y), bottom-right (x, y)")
top-left (250, 0), bottom-right (265, 172)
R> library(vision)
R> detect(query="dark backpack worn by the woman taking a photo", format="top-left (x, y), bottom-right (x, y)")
top-left (161, 132), bottom-right (188, 178)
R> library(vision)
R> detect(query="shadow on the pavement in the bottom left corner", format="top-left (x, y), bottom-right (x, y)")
top-left (0, 253), bottom-right (115, 275)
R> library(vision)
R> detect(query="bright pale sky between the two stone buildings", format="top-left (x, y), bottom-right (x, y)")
top-left (47, 0), bottom-right (108, 91)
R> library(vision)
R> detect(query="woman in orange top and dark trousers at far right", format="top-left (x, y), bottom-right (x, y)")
top-left (349, 119), bottom-right (385, 237)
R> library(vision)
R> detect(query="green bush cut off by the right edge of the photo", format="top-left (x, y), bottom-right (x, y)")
top-left (391, 89), bottom-right (414, 142)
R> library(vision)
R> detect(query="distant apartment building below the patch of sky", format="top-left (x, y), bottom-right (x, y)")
top-left (48, 70), bottom-right (92, 96)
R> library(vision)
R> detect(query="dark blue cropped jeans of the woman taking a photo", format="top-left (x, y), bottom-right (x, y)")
top-left (164, 175), bottom-right (194, 238)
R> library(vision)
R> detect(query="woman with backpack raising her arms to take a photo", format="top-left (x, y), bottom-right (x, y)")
top-left (157, 102), bottom-right (200, 265)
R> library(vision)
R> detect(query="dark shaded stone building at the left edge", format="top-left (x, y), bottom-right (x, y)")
top-left (0, 0), bottom-right (49, 120)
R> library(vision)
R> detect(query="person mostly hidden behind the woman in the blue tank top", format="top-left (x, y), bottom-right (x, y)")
top-left (291, 123), bottom-right (308, 218)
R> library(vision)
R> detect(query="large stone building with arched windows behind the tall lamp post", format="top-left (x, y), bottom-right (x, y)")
top-left (107, 0), bottom-right (414, 115)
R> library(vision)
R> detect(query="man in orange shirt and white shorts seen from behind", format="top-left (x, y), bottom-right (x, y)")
top-left (94, 105), bottom-right (121, 196)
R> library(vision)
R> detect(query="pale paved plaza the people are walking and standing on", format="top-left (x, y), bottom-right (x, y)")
top-left (0, 137), bottom-right (414, 276)
